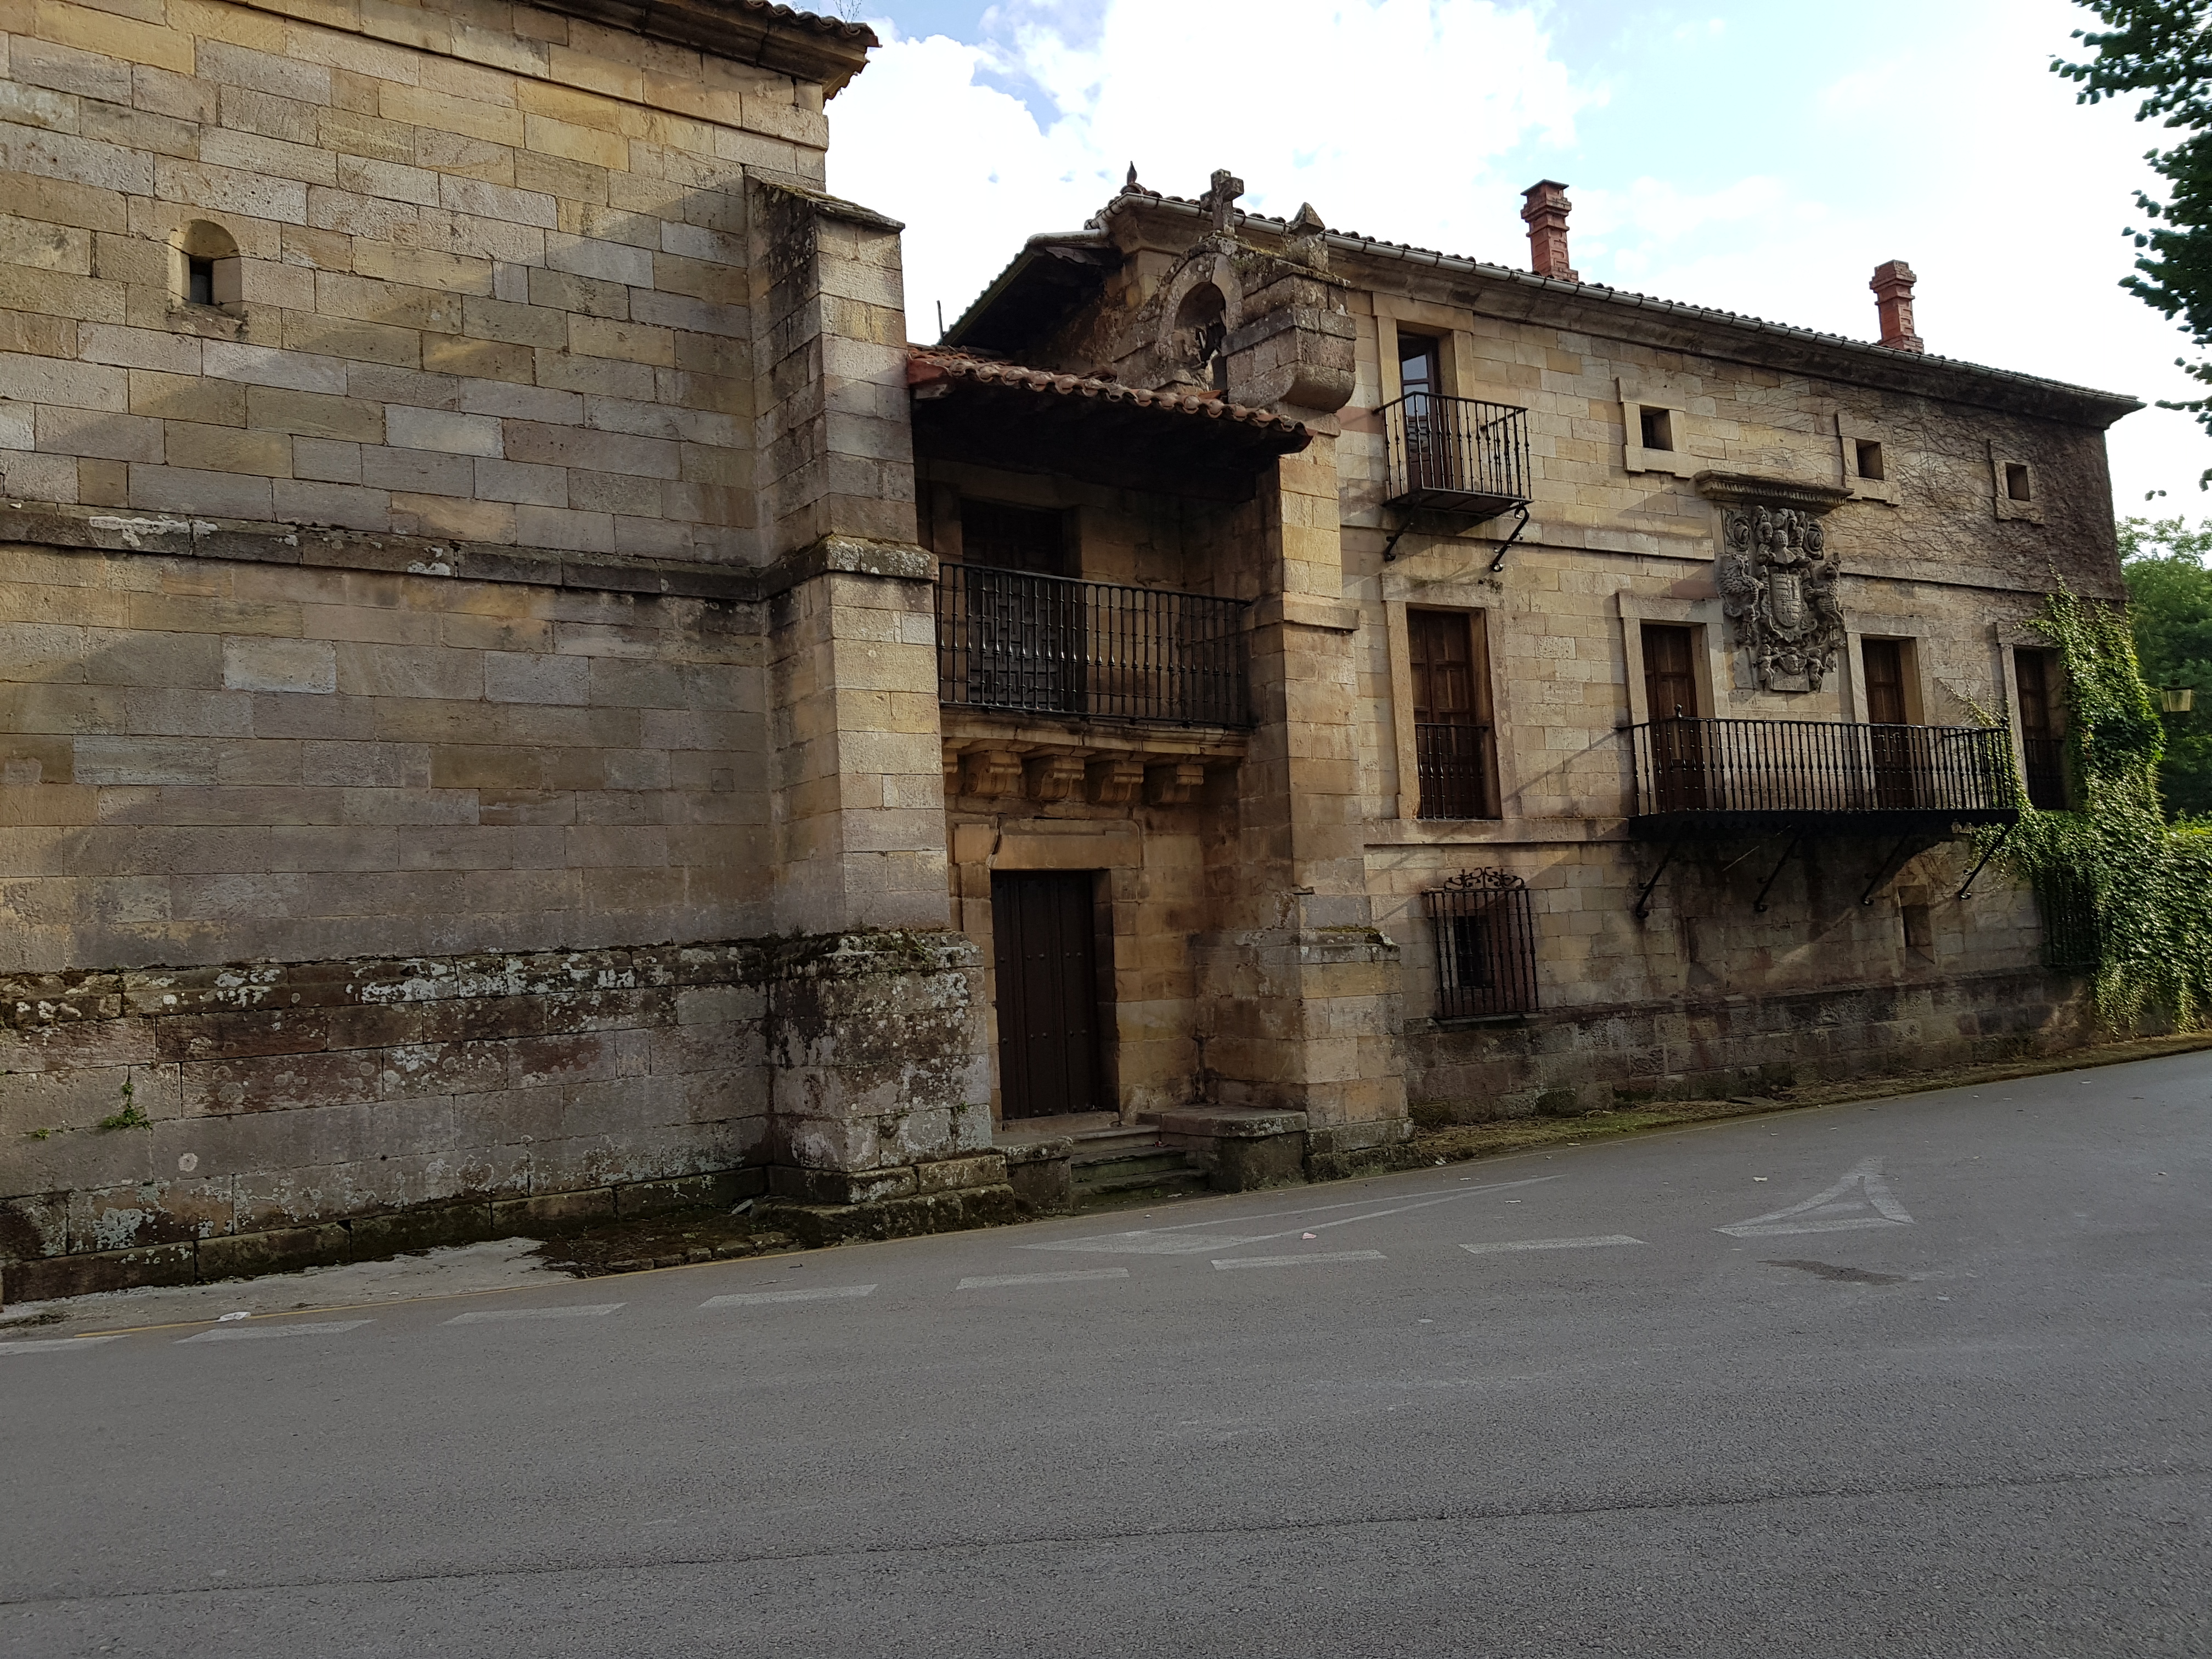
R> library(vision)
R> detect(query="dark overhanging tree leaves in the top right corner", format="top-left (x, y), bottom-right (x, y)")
top-left (2051, 0), bottom-right (2212, 473)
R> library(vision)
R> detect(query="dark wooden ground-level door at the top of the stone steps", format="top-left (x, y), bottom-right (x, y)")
top-left (991, 870), bottom-right (1113, 1119)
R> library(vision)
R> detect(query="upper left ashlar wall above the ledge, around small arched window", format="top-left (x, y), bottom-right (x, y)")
top-left (0, 0), bottom-right (827, 560)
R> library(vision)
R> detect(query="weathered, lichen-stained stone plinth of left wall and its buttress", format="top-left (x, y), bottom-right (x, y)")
top-left (0, 931), bottom-right (986, 1301)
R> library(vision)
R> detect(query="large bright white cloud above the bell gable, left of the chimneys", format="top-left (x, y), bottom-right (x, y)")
top-left (830, 0), bottom-right (1588, 338)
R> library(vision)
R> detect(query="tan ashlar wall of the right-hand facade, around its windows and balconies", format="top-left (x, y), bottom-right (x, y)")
top-left (1338, 259), bottom-right (2117, 1119)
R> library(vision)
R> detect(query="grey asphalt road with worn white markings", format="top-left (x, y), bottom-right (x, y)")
top-left (0, 1055), bottom-right (2212, 1659)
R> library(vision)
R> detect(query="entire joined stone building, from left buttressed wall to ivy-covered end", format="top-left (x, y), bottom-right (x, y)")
top-left (0, 0), bottom-right (2135, 1299)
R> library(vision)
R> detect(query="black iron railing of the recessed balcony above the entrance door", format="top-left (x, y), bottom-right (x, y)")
top-left (938, 564), bottom-right (1250, 725)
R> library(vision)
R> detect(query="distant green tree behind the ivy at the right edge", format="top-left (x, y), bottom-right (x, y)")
top-left (2119, 517), bottom-right (2212, 816)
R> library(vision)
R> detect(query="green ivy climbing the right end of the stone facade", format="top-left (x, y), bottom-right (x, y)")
top-left (1984, 589), bottom-right (2212, 1029)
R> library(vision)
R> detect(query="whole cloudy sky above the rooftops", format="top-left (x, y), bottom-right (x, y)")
top-left (821, 0), bottom-right (2212, 515)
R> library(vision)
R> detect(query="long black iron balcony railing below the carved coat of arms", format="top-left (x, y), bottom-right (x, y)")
top-left (1628, 719), bottom-right (2017, 830)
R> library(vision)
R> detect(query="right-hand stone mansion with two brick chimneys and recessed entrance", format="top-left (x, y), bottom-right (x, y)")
top-left (938, 172), bottom-right (2139, 1166)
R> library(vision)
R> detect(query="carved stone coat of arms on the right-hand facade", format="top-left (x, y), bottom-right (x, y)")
top-left (1719, 506), bottom-right (1845, 692)
